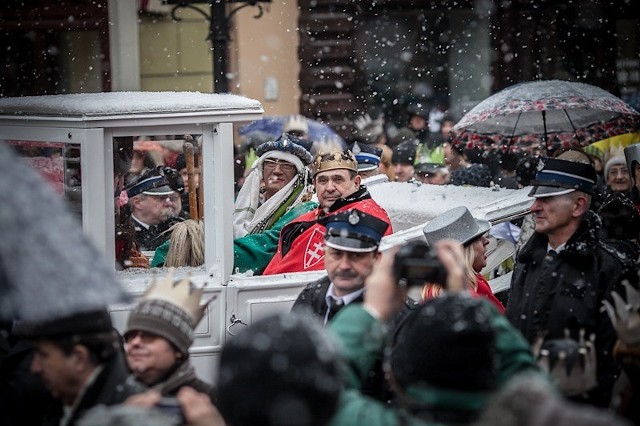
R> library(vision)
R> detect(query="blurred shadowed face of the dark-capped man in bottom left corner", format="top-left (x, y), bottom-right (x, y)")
top-left (30, 341), bottom-right (84, 405)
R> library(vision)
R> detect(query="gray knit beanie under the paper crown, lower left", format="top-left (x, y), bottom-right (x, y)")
top-left (125, 299), bottom-right (196, 355)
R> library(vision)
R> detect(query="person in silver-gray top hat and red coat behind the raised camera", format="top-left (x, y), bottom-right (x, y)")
top-left (422, 206), bottom-right (505, 313)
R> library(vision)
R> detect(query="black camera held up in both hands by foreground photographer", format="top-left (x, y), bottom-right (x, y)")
top-left (393, 241), bottom-right (447, 287)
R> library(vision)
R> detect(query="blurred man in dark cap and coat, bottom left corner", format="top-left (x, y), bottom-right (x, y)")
top-left (14, 310), bottom-right (144, 426)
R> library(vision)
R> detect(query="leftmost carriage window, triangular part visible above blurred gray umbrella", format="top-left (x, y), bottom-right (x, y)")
top-left (6, 140), bottom-right (82, 220)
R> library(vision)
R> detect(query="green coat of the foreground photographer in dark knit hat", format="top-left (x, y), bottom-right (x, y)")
top-left (330, 303), bottom-right (542, 426)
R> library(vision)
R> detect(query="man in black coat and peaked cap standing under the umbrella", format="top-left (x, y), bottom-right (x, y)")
top-left (506, 158), bottom-right (637, 406)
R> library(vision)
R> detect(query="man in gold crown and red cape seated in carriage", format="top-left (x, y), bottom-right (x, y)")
top-left (264, 148), bottom-right (393, 275)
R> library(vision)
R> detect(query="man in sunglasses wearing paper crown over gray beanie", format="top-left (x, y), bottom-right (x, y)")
top-left (124, 270), bottom-right (211, 396)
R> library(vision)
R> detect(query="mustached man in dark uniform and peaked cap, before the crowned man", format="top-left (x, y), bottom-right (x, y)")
top-left (292, 209), bottom-right (389, 325)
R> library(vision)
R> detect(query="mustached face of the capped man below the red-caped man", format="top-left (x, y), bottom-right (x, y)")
top-left (324, 247), bottom-right (378, 297)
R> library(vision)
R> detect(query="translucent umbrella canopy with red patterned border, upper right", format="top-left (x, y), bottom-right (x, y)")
top-left (451, 80), bottom-right (640, 155)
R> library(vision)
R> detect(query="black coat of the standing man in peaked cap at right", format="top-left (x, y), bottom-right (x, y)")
top-left (506, 211), bottom-right (637, 406)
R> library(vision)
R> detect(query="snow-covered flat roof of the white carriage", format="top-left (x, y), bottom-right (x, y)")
top-left (0, 92), bottom-right (263, 121)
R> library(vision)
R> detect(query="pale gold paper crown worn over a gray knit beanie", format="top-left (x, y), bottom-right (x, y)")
top-left (142, 268), bottom-right (208, 324)
